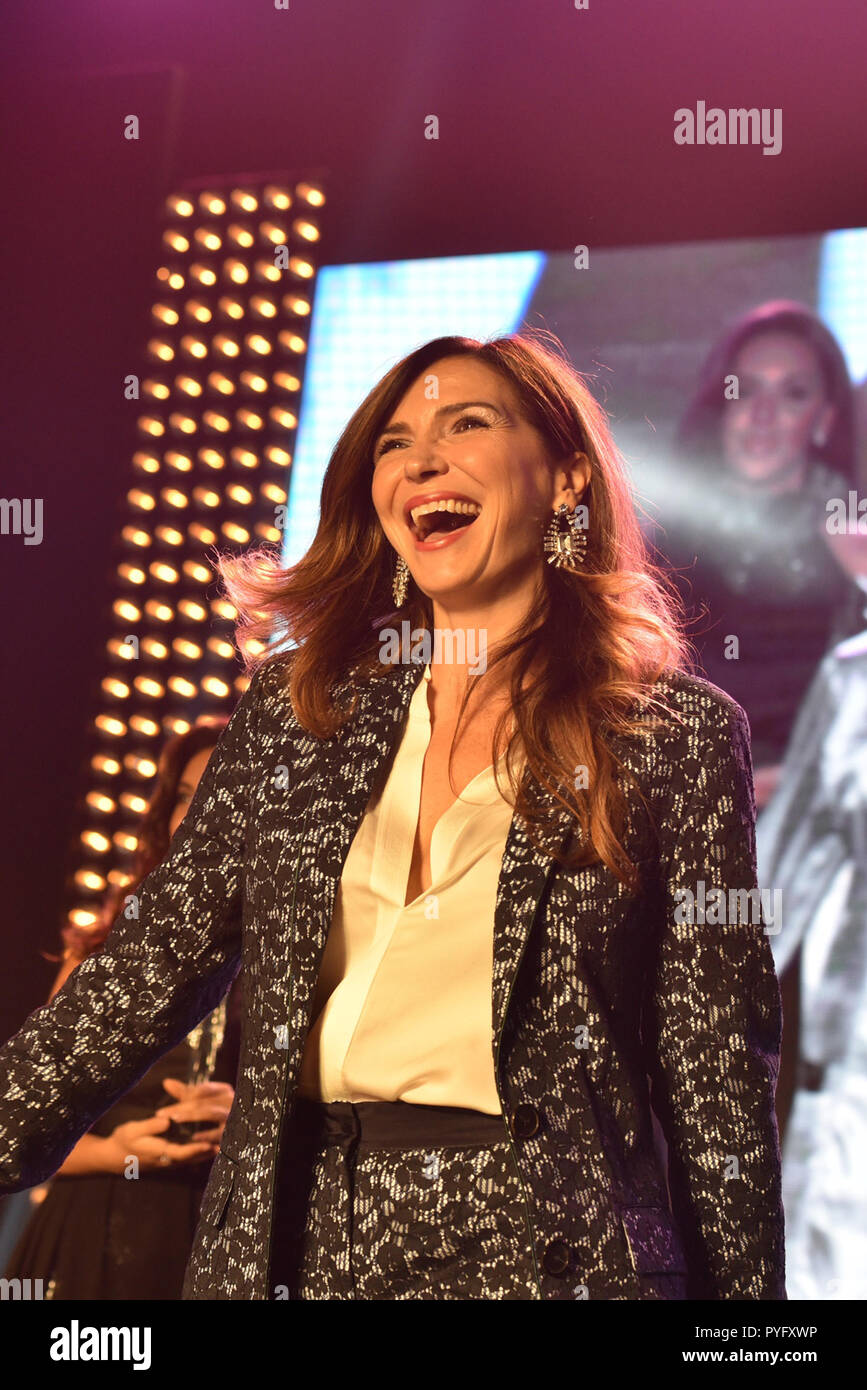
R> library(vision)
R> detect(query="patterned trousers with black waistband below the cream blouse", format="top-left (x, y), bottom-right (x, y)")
top-left (271, 1098), bottom-right (539, 1300)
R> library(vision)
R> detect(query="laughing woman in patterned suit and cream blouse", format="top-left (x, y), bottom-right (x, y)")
top-left (0, 335), bottom-right (785, 1300)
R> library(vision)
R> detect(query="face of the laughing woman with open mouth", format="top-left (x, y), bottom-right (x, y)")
top-left (372, 356), bottom-right (591, 605)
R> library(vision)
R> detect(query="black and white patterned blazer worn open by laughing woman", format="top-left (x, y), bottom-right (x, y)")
top-left (0, 655), bottom-right (785, 1300)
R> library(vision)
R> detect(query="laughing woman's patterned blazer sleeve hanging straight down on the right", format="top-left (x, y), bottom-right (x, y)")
top-left (645, 692), bottom-right (786, 1300)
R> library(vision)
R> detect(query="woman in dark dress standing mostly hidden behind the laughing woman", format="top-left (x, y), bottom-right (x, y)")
top-left (4, 719), bottom-right (240, 1301)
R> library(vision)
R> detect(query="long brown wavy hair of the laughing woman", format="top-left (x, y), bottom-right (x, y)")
top-left (218, 329), bottom-right (689, 887)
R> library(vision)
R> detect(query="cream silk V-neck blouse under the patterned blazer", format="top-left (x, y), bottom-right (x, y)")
top-left (299, 666), bottom-right (522, 1115)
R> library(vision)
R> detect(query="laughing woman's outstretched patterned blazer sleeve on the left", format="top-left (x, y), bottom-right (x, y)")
top-left (0, 667), bottom-right (263, 1193)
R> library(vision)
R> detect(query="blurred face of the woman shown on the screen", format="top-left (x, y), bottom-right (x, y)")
top-left (721, 332), bottom-right (834, 492)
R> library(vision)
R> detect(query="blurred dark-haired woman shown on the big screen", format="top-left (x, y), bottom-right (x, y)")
top-left (654, 300), bottom-right (863, 809)
